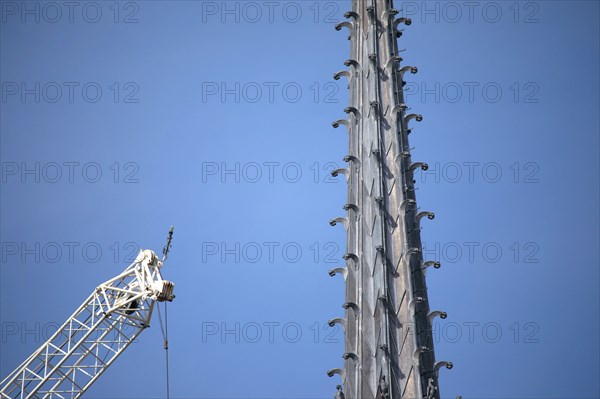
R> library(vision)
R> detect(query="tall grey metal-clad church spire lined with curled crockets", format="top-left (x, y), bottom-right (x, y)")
top-left (328, 0), bottom-right (452, 399)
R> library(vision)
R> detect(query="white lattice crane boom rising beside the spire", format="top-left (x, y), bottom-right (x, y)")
top-left (0, 227), bottom-right (175, 399)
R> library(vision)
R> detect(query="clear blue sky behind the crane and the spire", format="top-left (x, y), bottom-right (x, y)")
top-left (0, 0), bottom-right (600, 399)
